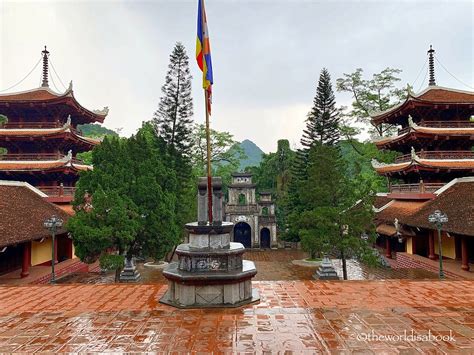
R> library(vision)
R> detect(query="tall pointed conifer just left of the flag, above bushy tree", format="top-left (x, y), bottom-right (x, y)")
top-left (153, 42), bottom-right (193, 157)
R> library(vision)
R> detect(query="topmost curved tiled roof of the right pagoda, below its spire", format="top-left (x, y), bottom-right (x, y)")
top-left (372, 86), bottom-right (474, 124)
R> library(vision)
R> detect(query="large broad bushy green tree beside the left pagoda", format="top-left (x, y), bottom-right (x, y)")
top-left (67, 124), bottom-right (180, 275)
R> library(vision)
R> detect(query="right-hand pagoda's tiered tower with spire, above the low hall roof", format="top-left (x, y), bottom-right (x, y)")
top-left (372, 49), bottom-right (474, 196)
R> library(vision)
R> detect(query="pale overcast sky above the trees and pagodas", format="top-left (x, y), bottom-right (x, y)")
top-left (0, 0), bottom-right (474, 152)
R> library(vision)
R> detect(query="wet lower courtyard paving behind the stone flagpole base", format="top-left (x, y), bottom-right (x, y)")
top-left (58, 250), bottom-right (438, 284)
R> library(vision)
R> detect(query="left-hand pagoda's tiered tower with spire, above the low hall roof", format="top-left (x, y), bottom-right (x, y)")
top-left (0, 47), bottom-right (108, 203)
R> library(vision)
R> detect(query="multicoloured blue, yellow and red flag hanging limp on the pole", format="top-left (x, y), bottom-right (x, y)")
top-left (196, 0), bottom-right (214, 113)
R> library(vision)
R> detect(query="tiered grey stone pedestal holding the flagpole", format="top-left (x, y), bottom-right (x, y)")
top-left (160, 177), bottom-right (259, 308)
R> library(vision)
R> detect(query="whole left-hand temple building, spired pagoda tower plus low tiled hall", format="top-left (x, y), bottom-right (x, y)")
top-left (0, 47), bottom-right (108, 282)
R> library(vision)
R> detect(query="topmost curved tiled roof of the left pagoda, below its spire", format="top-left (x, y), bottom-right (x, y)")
top-left (0, 85), bottom-right (108, 122)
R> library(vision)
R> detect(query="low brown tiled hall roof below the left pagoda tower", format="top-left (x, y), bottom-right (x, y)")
top-left (0, 180), bottom-right (69, 247)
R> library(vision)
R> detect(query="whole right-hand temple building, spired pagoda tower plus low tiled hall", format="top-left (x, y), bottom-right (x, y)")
top-left (372, 48), bottom-right (474, 276)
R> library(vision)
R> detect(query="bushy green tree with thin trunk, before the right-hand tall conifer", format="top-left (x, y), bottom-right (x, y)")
top-left (289, 144), bottom-right (375, 279)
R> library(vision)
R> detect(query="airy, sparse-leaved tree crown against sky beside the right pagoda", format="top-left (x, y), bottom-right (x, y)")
top-left (336, 68), bottom-right (407, 137)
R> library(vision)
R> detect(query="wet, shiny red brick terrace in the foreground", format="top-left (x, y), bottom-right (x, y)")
top-left (0, 280), bottom-right (474, 354)
